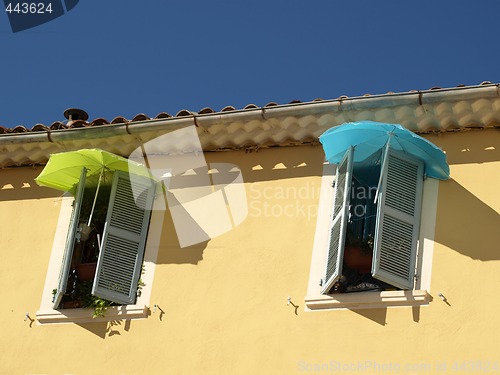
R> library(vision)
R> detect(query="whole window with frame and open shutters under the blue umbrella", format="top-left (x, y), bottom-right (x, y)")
top-left (306, 149), bottom-right (437, 310)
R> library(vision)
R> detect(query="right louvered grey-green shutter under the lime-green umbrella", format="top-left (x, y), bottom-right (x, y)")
top-left (92, 172), bottom-right (155, 304)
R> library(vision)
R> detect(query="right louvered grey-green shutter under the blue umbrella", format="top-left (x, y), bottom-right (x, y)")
top-left (372, 151), bottom-right (424, 289)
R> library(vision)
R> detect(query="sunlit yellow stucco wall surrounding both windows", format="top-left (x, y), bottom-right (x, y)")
top-left (0, 130), bottom-right (500, 374)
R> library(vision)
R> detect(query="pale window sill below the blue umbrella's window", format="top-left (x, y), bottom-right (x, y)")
top-left (305, 290), bottom-right (430, 311)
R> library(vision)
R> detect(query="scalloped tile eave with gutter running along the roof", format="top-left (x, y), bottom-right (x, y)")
top-left (0, 84), bottom-right (500, 167)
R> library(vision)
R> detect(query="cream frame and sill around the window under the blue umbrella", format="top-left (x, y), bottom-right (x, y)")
top-left (305, 152), bottom-right (439, 311)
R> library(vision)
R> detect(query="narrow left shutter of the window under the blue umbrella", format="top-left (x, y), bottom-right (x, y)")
top-left (321, 147), bottom-right (354, 293)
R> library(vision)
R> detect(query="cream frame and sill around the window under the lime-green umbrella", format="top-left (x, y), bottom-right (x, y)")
top-left (36, 172), bottom-right (164, 324)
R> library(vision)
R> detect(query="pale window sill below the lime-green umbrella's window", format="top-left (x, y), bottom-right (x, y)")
top-left (36, 305), bottom-right (149, 324)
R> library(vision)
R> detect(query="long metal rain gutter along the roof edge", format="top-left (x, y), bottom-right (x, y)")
top-left (0, 83), bottom-right (500, 145)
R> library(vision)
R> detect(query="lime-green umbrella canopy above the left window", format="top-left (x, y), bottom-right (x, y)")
top-left (35, 149), bottom-right (152, 193)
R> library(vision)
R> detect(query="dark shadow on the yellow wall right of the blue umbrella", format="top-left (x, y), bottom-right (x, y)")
top-left (426, 129), bottom-right (500, 261)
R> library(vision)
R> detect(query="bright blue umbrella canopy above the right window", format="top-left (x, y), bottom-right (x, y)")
top-left (319, 121), bottom-right (450, 180)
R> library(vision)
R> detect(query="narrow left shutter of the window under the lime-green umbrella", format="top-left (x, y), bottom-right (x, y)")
top-left (52, 167), bottom-right (87, 309)
